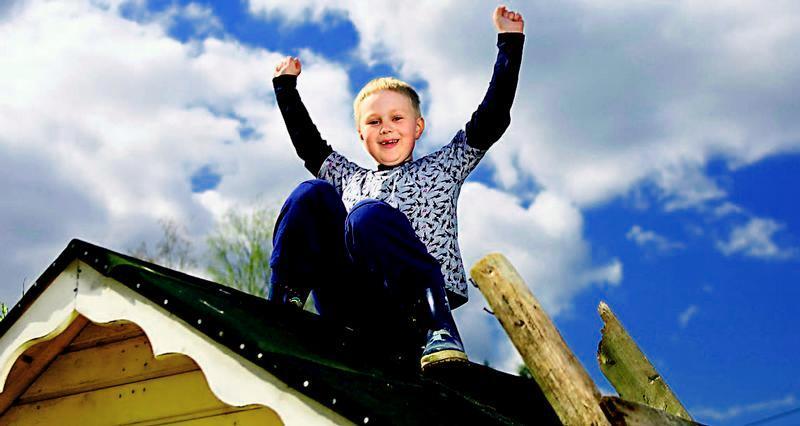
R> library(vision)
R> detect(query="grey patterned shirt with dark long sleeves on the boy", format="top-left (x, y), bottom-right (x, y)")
top-left (273, 33), bottom-right (525, 308)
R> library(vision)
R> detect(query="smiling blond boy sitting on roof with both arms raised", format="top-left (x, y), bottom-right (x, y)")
top-left (270, 6), bottom-right (524, 369)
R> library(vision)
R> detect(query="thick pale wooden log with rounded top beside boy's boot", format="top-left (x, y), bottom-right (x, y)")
top-left (470, 254), bottom-right (609, 426)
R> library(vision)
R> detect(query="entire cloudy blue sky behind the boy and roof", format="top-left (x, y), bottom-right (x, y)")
top-left (0, 0), bottom-right (800, 425)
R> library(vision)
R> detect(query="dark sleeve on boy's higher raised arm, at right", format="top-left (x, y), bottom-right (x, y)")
top-left (465, 33), bottom-right (525, 149)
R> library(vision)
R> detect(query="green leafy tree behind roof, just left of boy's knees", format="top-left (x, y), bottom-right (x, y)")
top-left (206, 208), bottom-right (275, 297)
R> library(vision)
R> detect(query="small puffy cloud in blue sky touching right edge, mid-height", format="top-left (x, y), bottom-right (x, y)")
top-left (717, 217), bottom-right (797, 260)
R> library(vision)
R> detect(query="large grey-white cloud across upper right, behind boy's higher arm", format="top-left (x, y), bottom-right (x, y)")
top-left (249, 0), bottom-right (800, 210)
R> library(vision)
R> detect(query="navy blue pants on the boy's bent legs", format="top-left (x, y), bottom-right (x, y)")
top-left (270, 179), bottom-right (452, 343)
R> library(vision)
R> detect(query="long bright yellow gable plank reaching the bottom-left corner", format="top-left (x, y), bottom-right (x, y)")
top-left (0, 370), bottom-right (248, 426)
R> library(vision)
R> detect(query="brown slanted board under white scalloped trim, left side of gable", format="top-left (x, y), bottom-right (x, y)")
top-left (0, 315), bottom-right (89, 414)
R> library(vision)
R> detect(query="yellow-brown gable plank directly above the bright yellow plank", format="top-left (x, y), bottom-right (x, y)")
top-left (19, 336), bottom-right (198, 403)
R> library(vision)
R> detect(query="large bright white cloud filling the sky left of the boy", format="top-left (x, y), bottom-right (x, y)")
top-left (0, 1), bottom-right (352, 302)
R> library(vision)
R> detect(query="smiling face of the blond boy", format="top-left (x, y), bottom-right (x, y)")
top-left (358, 90), bottom-right (425, 166)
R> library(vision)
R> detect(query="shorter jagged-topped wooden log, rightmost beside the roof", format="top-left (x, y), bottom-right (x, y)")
top-left (597, 302), bottom-right (692, 420)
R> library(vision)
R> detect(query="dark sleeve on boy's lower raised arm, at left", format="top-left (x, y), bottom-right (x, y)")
top-left (272, 75), bottom-right (333, 177)
